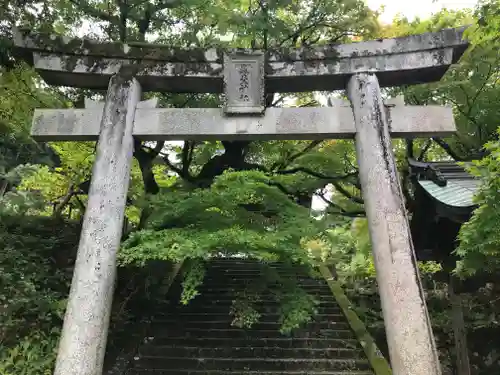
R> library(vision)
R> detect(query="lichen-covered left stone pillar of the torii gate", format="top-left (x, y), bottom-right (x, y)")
top-left (54, 73), bottom-right (141, 375)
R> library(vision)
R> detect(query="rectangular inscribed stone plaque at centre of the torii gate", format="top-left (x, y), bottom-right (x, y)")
top-left (224, 51), bottom-right (265, 115)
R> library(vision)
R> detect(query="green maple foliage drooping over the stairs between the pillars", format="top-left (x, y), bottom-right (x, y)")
top-left (119, 171), bottom-right (322, 332)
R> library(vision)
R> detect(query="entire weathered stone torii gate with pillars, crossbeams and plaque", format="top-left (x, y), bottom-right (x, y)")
top-left (15, 29), bottom-right (467, 375)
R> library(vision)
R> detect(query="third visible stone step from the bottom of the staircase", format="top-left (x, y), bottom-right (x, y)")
top-left (146, 323), bottom-right (355, 339)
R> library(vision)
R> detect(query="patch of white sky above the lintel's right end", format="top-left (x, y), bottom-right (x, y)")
top-left (366, 0), bottom-right (477, 23)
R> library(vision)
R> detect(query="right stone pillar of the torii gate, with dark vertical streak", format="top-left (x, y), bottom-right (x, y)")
top-left (347, 74), bottom-right (441, 375)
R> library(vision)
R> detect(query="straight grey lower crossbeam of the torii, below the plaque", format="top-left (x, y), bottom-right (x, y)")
top-left (31, 102), bottom-right (456, 141)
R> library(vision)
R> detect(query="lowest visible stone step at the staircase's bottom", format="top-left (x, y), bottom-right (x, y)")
top-left (129, 356), bottom-right (370, 372)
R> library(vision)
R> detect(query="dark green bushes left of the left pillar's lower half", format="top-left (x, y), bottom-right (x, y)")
top-left (0, 216), bottom-right (78, 375)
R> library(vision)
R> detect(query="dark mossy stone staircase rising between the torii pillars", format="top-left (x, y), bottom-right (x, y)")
top-left (126, 259), bottom-right (374, 375)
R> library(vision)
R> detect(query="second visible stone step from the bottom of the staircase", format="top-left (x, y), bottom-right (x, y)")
top-left (138, 345), bottom-right (364, 359)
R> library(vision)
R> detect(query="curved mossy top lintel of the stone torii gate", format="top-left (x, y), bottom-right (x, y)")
top-left (14, 27), bottom-right (468, 93)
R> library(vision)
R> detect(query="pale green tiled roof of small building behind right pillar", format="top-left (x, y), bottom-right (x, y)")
top-left (418, 179), bottom-right (479, 207)
